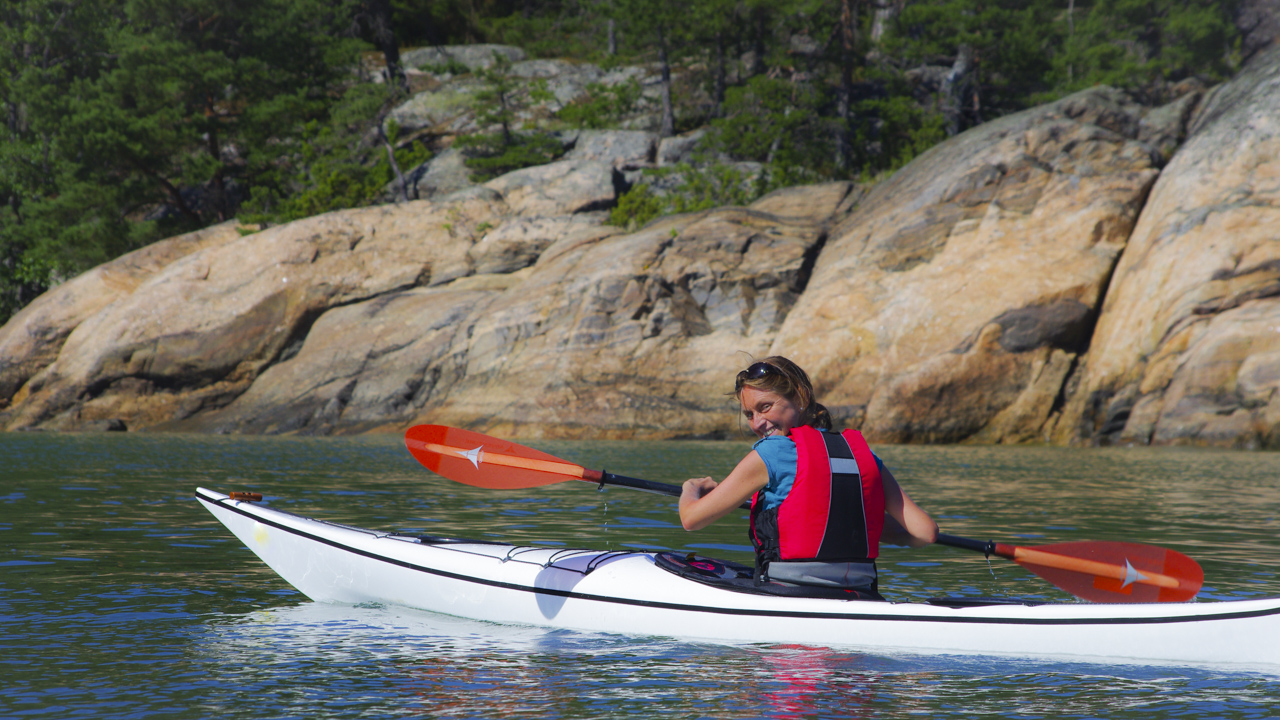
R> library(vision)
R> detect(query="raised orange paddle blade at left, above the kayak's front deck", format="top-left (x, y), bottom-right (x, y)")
top-left (404, 425), bottom-right (589, 489)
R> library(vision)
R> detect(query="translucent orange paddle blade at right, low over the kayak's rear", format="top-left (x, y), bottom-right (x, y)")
top-left (996, 541), bottom-right (1204, 602)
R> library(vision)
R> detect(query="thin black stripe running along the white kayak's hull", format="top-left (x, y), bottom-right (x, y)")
top-left (196, 492), bottom-right (1280, 625)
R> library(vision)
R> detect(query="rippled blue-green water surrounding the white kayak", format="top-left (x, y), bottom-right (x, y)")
top-left (0, 433), bottom-right (1280, 719)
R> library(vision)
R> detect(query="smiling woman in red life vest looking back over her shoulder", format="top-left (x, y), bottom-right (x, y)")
top-left (680, 355), bottom-right (938, 598)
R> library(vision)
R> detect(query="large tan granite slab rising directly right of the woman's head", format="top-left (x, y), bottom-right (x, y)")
top-left (771, 90), bottom-right (1158, 442)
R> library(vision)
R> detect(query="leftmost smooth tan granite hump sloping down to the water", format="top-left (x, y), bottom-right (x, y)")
top-left (0, 191), bottom-right (503, 429)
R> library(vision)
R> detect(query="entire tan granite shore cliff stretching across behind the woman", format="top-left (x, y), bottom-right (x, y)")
top-left (0, 49), bottom-right (1280, 446)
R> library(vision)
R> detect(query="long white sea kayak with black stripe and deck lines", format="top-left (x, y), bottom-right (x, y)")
top-left (196, 488), bottom-right (1280, 666)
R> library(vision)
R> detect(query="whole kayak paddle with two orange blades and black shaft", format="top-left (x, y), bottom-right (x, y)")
top-left (404, 425), bottom-right (1204, 602)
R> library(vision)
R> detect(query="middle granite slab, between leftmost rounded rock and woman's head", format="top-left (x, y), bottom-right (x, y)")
top-left (172, 183), bottom-right (851, 437)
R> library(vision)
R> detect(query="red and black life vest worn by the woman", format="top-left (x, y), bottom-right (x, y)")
top-left (751, 425), bottom-right (884, 566)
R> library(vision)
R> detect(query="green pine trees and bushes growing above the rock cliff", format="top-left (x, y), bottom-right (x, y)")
top-left (0, 0), bottom-right (1240, 320)
